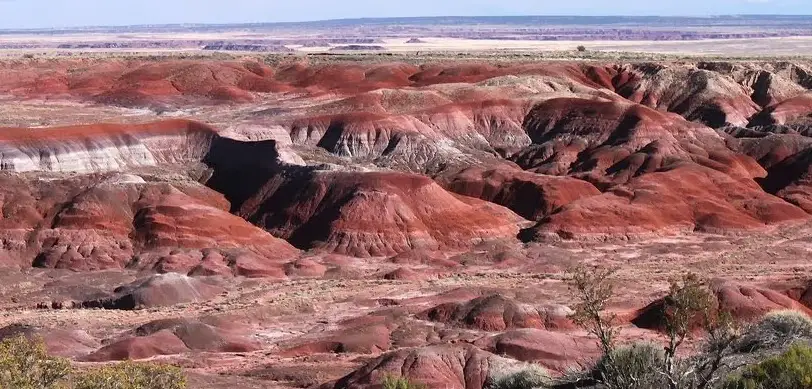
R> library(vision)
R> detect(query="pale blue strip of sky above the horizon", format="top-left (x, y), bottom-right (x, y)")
top-left (0, 0), bottom-right (812, 29)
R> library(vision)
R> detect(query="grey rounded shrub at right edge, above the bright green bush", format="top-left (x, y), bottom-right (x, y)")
top-left (737, 311), bottom-right (812, 352)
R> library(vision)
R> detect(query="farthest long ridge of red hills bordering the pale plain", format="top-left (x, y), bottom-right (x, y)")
top-left (0, 60), bottom-right (757, 118)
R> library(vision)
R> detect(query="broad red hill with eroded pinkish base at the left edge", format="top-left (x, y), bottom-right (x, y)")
top-left (7, 174), bottom-right (298, 274)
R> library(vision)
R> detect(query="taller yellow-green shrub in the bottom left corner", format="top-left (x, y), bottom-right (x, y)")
top-left (0, 336), bottom-right (70, 389)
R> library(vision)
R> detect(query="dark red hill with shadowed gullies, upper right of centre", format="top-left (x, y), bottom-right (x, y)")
top-left (512, 99), bottom-right (764, 183)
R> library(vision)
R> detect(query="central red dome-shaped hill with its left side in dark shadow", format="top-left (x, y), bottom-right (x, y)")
top-left (211, 169), bottom-right (523, 257)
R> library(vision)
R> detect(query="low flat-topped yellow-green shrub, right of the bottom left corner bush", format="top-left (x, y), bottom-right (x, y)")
top-left (74, 362), bottom-right (186, 389)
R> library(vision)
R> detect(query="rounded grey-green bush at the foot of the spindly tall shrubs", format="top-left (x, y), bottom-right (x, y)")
top-left (593, 343), bottom-right (667, 389)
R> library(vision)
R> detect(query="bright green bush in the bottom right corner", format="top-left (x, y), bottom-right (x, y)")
top-left (724, 345), bottom-right (812, 389)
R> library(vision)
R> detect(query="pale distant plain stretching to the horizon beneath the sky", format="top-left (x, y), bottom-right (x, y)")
top-left (0, 16), bottom-right (812, 58)
